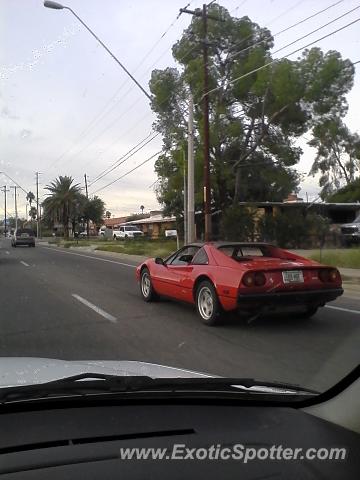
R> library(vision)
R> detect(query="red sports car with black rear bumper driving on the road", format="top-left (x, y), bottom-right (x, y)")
top-left (136, 242), bottom-right (343, 325)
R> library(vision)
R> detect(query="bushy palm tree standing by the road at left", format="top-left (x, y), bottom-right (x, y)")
top-left (43, 176), bottom-right (81, 238)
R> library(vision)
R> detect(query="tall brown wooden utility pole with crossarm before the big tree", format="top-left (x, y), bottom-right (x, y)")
top-left (180, 3), bottom-right (221, 242)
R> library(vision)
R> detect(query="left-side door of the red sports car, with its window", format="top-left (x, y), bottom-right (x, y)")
top-left (154, 245), bottom-right (199, 302)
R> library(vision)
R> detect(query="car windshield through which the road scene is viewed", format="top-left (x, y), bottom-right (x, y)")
top-left (0, 0), bottom-right (360, 402)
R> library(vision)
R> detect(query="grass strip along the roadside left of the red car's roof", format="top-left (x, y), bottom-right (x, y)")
top-left (96, 240), bottom-right (177, 258)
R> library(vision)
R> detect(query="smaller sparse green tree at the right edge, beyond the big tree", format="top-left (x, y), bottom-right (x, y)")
top-left (308, 116), bottom-right (360, 199)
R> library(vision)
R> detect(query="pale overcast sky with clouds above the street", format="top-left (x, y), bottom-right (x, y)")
top-left (0, 0), bottom-right (360, 217)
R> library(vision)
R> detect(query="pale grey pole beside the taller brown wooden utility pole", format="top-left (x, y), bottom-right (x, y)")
top-left (187, 93), bottom-right (195, 243)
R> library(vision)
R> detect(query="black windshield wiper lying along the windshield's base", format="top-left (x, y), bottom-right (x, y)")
top-left (0, 372), bottom-right (319, 403)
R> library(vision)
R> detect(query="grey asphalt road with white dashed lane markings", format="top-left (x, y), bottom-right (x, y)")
top-left (0, 239), bottom-right (360, 390)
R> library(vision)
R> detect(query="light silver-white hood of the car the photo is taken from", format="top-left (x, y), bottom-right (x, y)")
top-left (0, 357), bottom-right (212, 388)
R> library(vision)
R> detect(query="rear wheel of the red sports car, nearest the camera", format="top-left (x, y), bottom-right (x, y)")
top-left (195, 280), bottom-right (222, 325)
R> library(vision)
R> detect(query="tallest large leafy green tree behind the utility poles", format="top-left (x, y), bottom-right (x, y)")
top-left (150, 4), bottom-right (354, 215)
